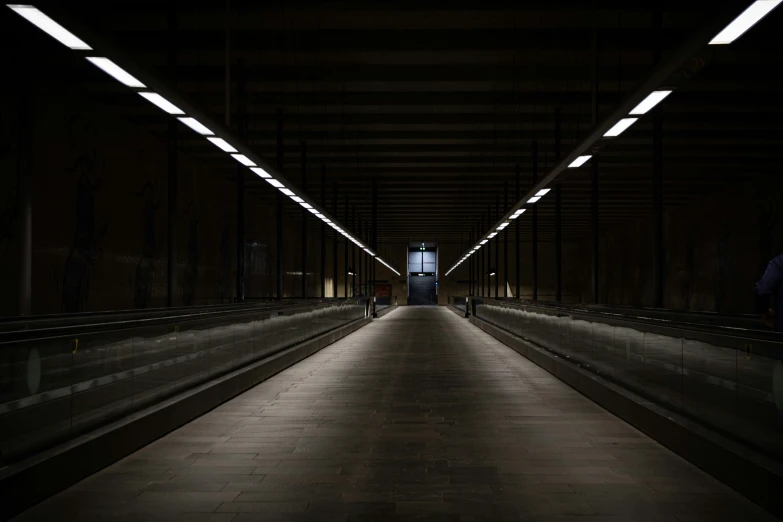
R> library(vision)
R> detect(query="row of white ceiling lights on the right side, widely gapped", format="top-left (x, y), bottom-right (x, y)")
top-left (446, 0), bottom-right (783, 275)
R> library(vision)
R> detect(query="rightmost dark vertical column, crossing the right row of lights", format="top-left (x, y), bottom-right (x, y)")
top-left (652, 8), bottom-right (663, 308)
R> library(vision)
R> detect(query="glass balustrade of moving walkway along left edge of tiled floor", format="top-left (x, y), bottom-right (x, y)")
top-left (0, 298), bottom-right (368, 463)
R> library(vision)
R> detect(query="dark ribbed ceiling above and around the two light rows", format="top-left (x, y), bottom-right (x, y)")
top-left (3, 0), bottom-right (783, 249)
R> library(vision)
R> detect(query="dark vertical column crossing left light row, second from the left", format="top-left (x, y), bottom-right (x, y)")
top-left (166, 0), bottom-right (178, 307)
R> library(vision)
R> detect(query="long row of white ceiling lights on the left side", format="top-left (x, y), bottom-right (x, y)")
top-left (7, 4), bottom-right (400, 276)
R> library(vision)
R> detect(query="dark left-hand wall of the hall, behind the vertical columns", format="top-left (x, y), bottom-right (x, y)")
top-left (0, 86), bottom-right (362, 316)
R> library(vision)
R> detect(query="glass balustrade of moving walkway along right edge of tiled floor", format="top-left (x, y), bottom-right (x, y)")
top-left (471, 298), bottom-right (783, 460)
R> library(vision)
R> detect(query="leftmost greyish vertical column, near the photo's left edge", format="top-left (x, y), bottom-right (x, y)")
top-left (16, 81), bottom-right (33, 315)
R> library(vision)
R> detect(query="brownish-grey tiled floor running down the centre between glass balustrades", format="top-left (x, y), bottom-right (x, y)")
top-left (12, 307), bottom-right (775, 522)
